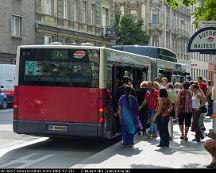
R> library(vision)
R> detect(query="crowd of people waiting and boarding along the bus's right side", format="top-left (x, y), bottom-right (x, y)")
top-left (115, 76), bottom-right (216, 168)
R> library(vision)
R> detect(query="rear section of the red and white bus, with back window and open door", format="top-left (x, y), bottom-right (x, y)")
top-left (13, 45), bottom-right (151, 139)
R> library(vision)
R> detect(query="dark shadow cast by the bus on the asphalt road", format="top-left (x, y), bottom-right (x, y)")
top-left (0, 138), bottom-right (118, 168)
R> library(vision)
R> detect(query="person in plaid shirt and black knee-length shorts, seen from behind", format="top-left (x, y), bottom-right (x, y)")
top-left (176, 81), bottom-right (192, 141)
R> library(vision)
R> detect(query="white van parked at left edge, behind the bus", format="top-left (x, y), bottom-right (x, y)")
top-left (0, 64), bottom-right (16, 103)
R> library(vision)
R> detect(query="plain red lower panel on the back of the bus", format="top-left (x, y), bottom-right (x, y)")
top-left (16, 86), bottom-right (99, 123)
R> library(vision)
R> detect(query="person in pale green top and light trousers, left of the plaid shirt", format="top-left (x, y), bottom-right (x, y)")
top-left (166, 83), bottom-right (177, 140)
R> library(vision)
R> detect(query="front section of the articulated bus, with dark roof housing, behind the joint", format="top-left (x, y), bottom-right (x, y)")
top-left (112, 45), bottom-right (189, 82)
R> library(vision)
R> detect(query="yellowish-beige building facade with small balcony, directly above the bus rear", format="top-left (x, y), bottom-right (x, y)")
top-left (36, 0), bottom-right (115, 47)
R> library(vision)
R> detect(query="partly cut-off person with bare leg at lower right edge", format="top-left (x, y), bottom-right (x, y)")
top-left (204, 130), bottom-right (216, 168)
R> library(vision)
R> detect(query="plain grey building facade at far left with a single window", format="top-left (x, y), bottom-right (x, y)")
top-left (0, 0), bottom-right (35, 64)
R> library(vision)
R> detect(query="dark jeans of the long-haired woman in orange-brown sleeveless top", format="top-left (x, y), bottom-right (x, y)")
top-left (157, 116), bottom-right (169, 147)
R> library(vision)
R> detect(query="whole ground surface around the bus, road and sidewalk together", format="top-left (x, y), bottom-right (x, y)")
top-left (0, 109), bottom-right (212, 169)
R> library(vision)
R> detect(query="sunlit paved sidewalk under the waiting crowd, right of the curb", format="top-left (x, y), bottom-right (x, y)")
top-left (71, 118), bottom-right (212, 169)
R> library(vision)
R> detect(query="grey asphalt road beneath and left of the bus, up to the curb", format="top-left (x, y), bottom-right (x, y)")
top-left (0, 109), bottom-right (116, 168)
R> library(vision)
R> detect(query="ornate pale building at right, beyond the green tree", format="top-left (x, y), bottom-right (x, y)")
top-left (116, 0), bottom-right (208, 79)
